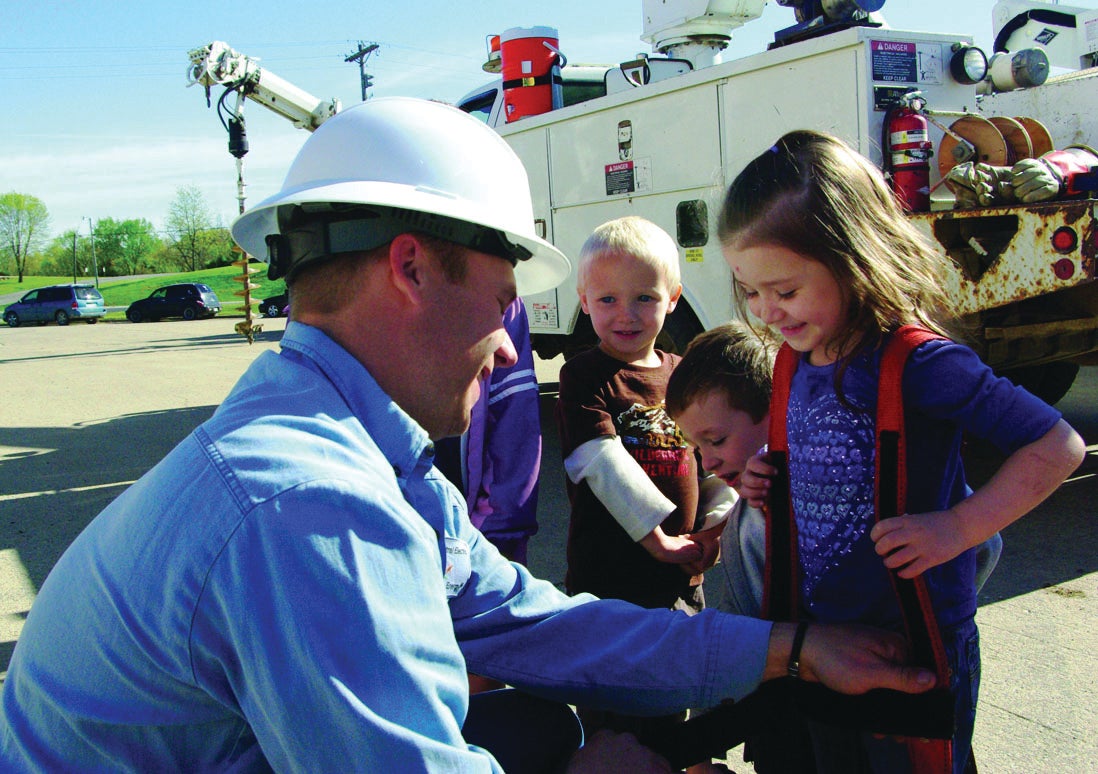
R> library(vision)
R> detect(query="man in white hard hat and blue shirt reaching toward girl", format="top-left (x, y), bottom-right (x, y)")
top-left (0, 98), bottom-right (929, 772)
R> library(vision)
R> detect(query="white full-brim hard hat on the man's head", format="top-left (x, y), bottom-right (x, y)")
top-left (232, 97), bottom-right (571, 294)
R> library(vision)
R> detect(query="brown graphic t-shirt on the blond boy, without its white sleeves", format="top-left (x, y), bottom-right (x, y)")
top-left (557, 349), bottom-right (698, 607)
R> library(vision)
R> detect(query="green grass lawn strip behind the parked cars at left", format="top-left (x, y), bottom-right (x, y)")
top-left (0, 262), bottom-right (285, 319)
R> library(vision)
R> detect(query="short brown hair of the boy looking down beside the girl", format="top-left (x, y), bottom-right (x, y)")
top-left (666, 323), bottom-right (777, 423)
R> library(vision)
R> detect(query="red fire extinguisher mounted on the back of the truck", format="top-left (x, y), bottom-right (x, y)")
top-left (884, 92), bottom-right (933, 212)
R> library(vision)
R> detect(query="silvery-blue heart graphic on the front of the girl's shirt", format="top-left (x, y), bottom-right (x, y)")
top-left (787, 392), bottom-right (875, 603)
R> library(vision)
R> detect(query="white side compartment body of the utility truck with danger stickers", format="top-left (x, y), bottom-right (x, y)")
top-left (474, 27), bottom-right (976, 334)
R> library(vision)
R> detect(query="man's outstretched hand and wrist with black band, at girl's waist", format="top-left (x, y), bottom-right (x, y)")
top-left (763, 624), bottom-right (934, 694)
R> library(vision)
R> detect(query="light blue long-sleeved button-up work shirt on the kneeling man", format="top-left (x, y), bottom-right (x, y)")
top-left (0, 323), bottom-right (770, 772)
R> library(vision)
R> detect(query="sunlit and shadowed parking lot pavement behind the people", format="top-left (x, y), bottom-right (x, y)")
top-left (0, 317), bottom-right (1098, 774)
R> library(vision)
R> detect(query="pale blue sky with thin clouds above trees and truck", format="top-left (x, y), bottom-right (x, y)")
top-left (0, 0), bottom-right (1045, 240)
